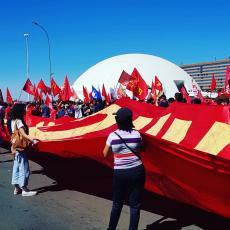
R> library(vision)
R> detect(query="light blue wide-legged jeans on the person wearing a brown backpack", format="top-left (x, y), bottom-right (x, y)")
top-left (12, 151), bottom-right (30, 188)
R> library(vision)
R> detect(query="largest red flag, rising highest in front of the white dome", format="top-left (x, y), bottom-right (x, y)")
top-left (127, 68), bottom-right (148, 100)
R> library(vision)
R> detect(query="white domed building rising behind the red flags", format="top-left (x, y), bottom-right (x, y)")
top-left (73, 54), bottom-right (192, 98)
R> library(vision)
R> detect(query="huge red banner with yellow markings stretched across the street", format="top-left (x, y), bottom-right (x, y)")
top-left (27, 98), bottom-right (230, 217)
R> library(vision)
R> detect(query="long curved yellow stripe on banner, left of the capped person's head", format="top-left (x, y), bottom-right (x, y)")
top-left (30, 104), bottom-right (120, 140)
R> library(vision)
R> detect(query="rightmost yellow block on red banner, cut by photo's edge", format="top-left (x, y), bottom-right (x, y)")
top-left (195, 122), bottom-right (230, 155)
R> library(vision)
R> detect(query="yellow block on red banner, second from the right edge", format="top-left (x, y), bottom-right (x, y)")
top-left (162, 118), bottom-right (192, 144)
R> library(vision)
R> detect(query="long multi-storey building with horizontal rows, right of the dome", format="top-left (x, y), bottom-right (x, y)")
top-left (180, 59), bottom-right (230, 91)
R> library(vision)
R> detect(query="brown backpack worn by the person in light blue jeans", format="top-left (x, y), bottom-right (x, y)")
top-left (10, 120), bottom-right (30, 151)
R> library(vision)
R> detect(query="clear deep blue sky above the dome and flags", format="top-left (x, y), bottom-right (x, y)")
top-left (0, 0), bottom-right (230, 99)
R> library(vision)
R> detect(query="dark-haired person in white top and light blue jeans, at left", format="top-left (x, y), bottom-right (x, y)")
top-left (11, 104), bottom-right (37, 196)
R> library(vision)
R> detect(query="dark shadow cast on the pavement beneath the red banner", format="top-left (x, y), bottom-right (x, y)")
top-left (27, 152), bottom-right (230, 230)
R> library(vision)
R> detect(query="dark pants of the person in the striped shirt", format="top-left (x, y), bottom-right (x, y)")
top-left (108, 165), bottom-right (145, 230)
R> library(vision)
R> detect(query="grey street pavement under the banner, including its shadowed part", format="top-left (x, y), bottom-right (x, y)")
top-left (0, 148), bottom-right (230, 230)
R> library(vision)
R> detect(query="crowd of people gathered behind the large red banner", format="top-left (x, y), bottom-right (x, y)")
top-left (0, 92), bottom-right (230, 134)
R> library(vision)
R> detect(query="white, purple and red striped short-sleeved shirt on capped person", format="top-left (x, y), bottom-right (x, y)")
top-left (106, 130), bottom-right (142, 169)
